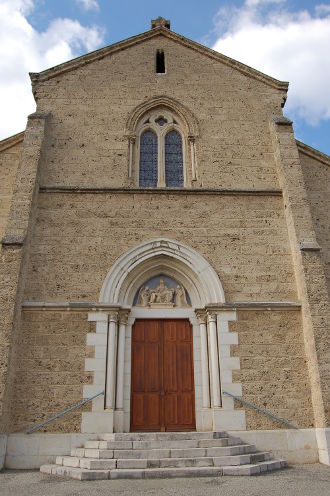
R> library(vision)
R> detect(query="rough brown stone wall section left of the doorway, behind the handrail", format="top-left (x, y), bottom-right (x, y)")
top-left (11, 311), bottom-right (93, 432)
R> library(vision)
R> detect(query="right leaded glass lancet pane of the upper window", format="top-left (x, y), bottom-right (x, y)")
top-left (165, 130), bottom-right (184, 188)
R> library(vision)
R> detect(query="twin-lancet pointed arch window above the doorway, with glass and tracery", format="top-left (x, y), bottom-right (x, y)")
top-left (135, 109), bottom-right (187, 188)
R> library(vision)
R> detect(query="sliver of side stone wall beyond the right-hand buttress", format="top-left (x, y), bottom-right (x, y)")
top-left (299, 151), bottom-right (330, 298)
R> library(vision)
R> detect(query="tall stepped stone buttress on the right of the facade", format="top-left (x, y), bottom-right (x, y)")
top-left (270, 117), bottom-right (330, 428)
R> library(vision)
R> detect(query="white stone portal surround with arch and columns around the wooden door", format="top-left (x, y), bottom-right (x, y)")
top-left (82, 238), bottom-right (245, 432)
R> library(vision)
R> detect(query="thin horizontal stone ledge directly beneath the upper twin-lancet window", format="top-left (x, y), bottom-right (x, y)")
top-left (40, 186), bottom-right (282, 196)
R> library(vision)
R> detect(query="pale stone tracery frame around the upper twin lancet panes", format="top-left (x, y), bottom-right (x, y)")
top-left (134, 108), bottom-right (189, 188)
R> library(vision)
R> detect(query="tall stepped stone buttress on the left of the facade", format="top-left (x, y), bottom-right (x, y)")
top-left (0, 112), bottom-right (48, 432)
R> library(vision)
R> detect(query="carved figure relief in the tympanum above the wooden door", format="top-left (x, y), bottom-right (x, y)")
top-left (137, 279), bottom-right (190, 308)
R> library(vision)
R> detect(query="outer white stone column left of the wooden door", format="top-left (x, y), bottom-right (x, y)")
top-left (105, 312), bottom-right (118, 410)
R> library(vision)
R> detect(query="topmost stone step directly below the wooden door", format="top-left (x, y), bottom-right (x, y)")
top-left (98, 431), bottom-right (228, 442)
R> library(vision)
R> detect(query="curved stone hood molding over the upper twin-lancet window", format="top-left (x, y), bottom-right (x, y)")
top-left (125, 96), bottom-right (199, 139)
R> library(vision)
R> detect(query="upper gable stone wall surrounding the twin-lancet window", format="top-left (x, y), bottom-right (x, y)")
top-left (35, 36), bottom-right (283, 188)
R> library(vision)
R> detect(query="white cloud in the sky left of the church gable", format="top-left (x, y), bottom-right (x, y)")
top-left (0, 0), bottom-right (104, 139)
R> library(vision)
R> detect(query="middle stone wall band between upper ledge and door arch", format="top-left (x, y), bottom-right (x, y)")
top-left (25, 192), bottom-right (296, 301)
